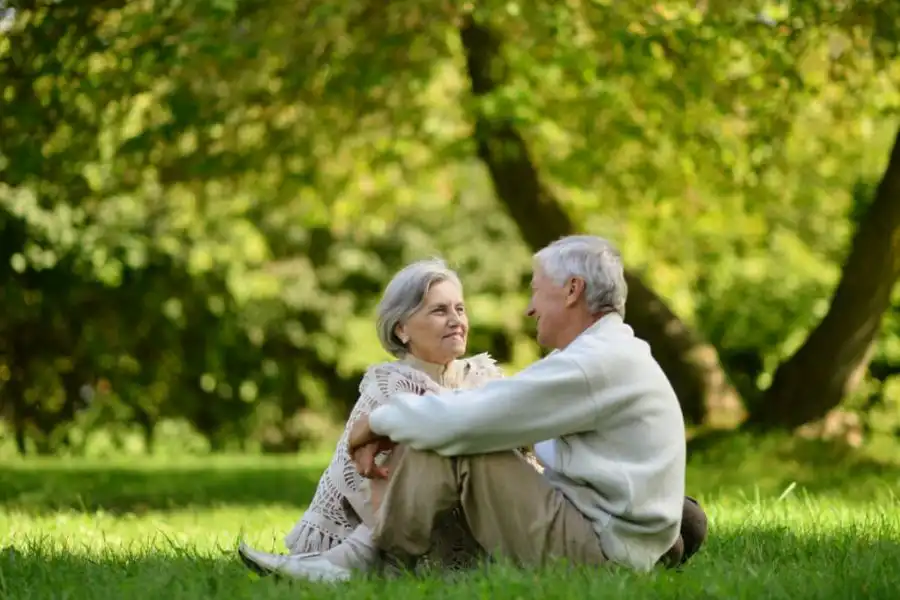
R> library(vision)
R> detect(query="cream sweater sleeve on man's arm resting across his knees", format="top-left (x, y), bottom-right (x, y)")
top-left (369, 353), bottom-right (598, 456)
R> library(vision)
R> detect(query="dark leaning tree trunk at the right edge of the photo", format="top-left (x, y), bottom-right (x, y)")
top-left (747, 126), bottom-right (900, 429)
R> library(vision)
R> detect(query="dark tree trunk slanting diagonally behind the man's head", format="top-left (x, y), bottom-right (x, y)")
top-left (460, 17), bottom-right (744, 427)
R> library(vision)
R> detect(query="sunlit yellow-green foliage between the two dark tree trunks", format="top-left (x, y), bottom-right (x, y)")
top-left (486, 3), bottom-right (900, 402)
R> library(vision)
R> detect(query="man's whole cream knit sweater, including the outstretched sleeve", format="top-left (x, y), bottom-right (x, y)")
top-left (370, 314), bottom-right (686, 571)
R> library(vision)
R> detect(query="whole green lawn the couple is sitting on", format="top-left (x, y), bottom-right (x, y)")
top-left (0, 439), bottom-right (900, 600)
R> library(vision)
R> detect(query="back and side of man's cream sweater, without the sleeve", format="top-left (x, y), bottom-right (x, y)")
top-left (545, 314), bottom-right (685, 568)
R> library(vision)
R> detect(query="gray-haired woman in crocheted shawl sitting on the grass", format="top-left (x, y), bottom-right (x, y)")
top-left (239, 259), bottom-right (502, 579)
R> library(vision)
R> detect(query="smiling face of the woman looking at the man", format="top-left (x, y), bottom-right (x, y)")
top-left (395, 281), bottom-right (469, 365)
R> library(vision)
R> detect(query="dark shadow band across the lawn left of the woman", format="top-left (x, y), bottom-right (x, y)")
top-left (0, 459), bottom-right (322, 514)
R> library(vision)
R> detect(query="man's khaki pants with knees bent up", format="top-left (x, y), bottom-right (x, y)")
top-left (373, 448), bottom-right (606, 566)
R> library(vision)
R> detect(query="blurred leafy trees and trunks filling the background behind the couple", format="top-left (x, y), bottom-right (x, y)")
top-left (0, 0), bottom-right (900, 453)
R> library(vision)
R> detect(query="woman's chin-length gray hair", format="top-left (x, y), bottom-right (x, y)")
top-left (376, 258), bottom-right (462, 358)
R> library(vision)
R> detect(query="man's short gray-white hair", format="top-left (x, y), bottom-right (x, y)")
top-left (534, 235), bottom-right (628, 318)
